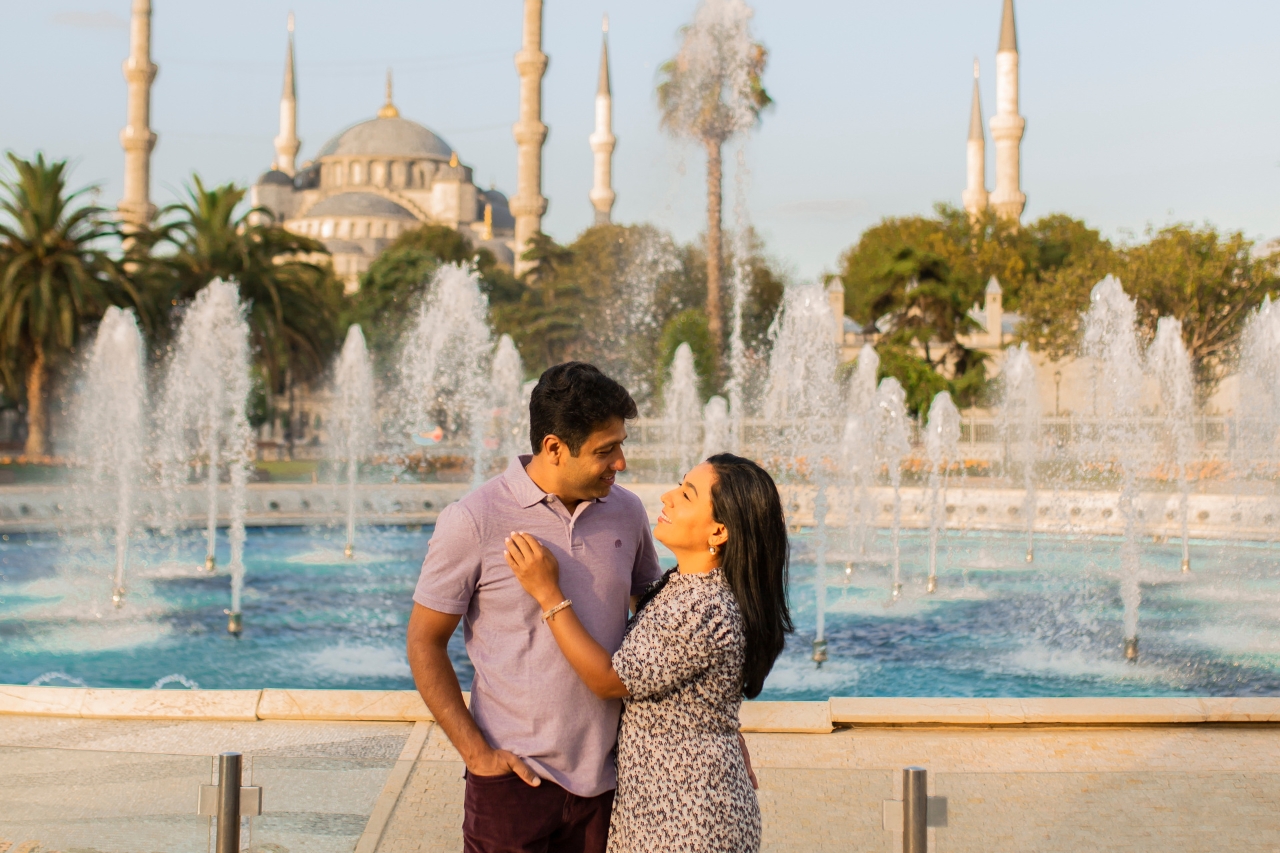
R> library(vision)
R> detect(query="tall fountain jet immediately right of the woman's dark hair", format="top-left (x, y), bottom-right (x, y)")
top-left (764, 284), bottom-right (840, 666)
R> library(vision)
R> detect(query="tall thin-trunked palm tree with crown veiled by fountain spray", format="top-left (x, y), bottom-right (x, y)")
top-left (658, 0), bottom-right (773, 373)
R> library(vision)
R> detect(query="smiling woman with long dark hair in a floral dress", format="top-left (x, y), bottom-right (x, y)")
top-left (507, 453), bottom-right (792, 853)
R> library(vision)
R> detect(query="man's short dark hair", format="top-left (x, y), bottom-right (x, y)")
top-left (529, 361), bottom-right (639, 456)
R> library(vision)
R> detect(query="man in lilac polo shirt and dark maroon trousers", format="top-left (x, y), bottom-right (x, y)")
top-left (408, 361), bottom-right (660, 853)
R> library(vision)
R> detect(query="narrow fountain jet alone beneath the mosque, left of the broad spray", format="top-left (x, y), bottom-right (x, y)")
top-left (329, 323), bottom-right (376, 560)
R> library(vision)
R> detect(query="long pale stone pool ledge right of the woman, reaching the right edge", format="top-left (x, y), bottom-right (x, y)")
top-left (829, 697), bottom-right (1280, 726)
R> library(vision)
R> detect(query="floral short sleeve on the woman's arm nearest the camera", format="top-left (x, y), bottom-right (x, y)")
top-left (613, 584), bottom-right (733, 699)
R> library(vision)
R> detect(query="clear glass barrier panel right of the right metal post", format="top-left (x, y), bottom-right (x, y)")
top-left (931, 771), bottom-right (1280, 853)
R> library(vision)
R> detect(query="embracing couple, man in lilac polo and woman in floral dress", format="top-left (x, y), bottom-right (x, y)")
top-left (408, 362), bottom-right (791, 853)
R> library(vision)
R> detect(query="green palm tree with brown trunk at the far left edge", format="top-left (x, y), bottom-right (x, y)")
top-left (0, 154), bottom-right (138, 457)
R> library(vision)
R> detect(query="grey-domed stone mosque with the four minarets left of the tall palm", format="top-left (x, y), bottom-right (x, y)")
top-left (119, 0), bottom-right (616, 292)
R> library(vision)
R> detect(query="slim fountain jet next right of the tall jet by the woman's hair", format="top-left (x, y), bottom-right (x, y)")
top-left (840, 343), bottom-right (879, 560)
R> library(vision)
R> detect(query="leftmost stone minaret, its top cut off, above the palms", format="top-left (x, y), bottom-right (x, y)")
top-left (119, 0), bottom-right (159, 229)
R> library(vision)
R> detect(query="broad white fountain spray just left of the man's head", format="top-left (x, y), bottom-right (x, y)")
top-left (398, 264), bottom-right (493, 485)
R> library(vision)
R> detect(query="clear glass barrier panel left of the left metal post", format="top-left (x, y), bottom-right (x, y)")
top-left (0, 747), bottom-right (214, 853)
